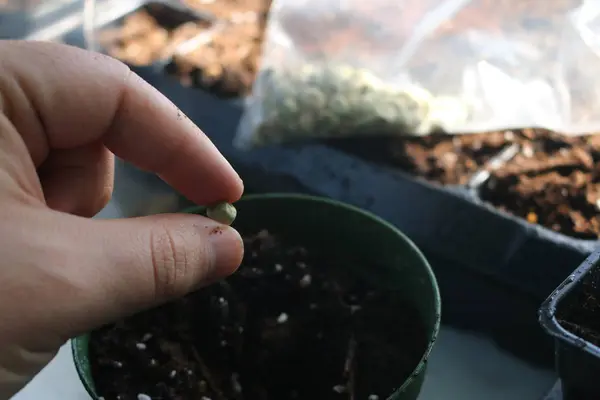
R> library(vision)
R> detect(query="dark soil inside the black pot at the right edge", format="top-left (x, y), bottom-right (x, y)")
top-left (556, 270), bottom-right (600, 346)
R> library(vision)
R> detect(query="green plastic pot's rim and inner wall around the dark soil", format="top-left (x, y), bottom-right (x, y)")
top-left (72, 194), bottom-right (441, 400)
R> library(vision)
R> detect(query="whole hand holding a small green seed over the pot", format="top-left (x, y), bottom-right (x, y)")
top-left (0, 41), bottom-right (243, 399)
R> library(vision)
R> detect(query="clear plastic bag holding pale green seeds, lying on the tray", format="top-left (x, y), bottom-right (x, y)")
top-left (236, 0), bottom-right (600, 148)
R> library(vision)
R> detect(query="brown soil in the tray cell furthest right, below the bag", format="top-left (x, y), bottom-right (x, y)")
top-left (481, 134), bottom-right (600, 239)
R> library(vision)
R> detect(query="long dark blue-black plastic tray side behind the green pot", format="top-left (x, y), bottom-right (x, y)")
top-left (29, 0), bottom-right (596, 364)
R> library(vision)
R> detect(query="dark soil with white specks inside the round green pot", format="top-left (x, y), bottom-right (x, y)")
top-left (90, 231), bottom-right (427, 400)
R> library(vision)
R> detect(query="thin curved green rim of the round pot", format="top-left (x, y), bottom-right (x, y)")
top-left (71, 193), bottom-right (442, 400)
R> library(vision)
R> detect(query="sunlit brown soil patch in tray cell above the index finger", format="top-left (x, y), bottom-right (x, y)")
top-left (98, 3), bottom-right (212, 66)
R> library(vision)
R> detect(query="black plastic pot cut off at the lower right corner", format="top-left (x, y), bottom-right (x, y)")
top-left (539, 250), bottom-right (600, 400)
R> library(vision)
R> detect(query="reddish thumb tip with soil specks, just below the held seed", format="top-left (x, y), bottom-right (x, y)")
top-left (208, 224), bottom-right (244, 279)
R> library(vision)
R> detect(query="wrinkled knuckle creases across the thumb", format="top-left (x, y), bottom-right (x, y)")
top-left (150, 227), bottom-right (189, 298)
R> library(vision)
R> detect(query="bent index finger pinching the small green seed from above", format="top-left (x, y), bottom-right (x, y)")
top-left (0, 41), bottom-right (243, 204)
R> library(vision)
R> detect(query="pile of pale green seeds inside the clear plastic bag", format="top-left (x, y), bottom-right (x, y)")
top-left (235, 63), bottom-right (468, 148)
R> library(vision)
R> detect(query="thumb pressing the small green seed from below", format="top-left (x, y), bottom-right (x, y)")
top-left (51, 214), bottom-right (244, 336)
